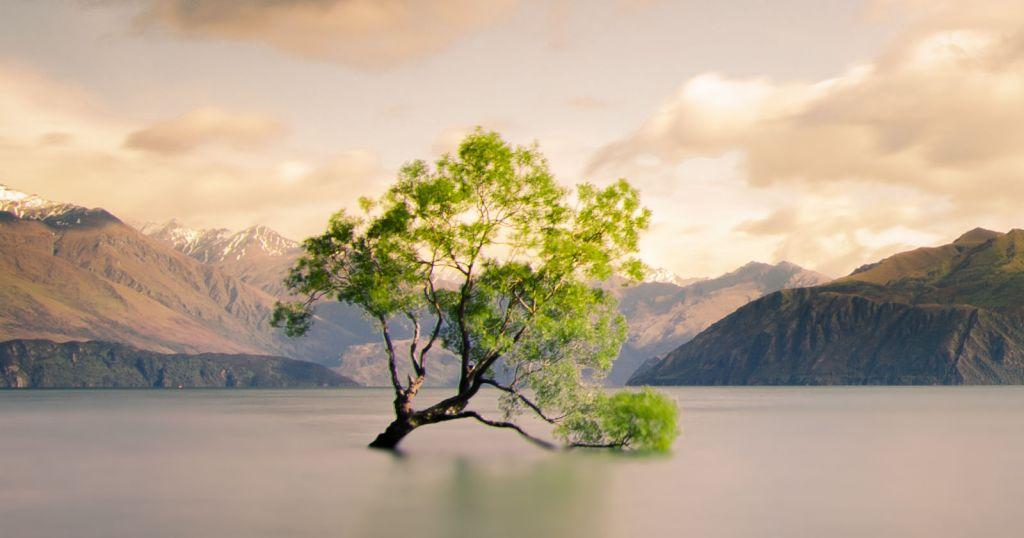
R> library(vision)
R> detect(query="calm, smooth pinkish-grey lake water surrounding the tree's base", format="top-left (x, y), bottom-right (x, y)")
top-left (0, 387), bottom-right (1024, 538)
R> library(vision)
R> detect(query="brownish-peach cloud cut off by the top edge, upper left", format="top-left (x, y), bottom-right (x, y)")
top-left (139, 0), bottom-right (518, 71)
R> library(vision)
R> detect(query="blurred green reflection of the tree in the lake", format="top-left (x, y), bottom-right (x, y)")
top-left (355, 454), bottom-right (607, 538)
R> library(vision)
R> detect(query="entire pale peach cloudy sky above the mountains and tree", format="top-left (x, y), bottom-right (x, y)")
top-left (0, 0), bottom-right (1024, 277)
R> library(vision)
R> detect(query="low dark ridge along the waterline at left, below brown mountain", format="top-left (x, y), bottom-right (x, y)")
top-left (0, 340), bottom-right (355, 388)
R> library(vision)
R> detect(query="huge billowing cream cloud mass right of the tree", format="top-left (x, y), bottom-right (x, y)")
top-left (589, 0), bottom-right (1024, 273)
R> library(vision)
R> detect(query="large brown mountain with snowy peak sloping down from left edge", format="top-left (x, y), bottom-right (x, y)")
top-left (0, 184), bottom-right (359, 364)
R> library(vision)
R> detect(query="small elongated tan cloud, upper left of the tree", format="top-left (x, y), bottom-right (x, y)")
top-left (124, 107), bottom-right (285, 155)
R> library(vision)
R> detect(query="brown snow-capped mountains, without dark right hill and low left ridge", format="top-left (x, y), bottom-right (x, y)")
top-left (0, 185), bottom-right (828, 385)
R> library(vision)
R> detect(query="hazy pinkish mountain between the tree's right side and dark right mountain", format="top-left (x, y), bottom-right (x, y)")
top-left (605, 261), bottom-right (830, 384)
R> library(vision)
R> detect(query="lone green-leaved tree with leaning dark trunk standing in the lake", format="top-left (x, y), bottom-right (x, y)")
top-left (272, 130), bottom-right (677, 451)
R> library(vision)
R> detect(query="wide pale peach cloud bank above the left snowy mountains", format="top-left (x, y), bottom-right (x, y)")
top-left (0, 65), bottom-right (390, 238)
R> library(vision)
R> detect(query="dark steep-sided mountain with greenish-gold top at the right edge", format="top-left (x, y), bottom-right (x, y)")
top-left (630, 229), bottom-right (1024, 384)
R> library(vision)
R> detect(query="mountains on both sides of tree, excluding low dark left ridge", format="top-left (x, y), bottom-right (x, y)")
top-left (12, 185), bottom-right (1024, 385)
